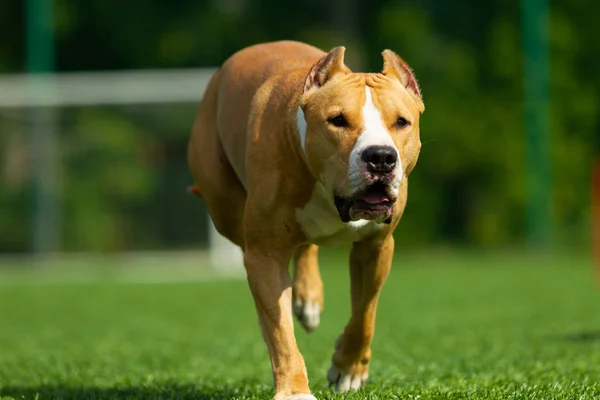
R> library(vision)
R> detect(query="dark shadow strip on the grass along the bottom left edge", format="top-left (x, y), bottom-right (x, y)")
top-left (0, 384), bottom-right (272, 400)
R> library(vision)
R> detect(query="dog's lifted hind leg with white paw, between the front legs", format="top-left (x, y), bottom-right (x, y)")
top-left (293, 244), bottom-right (323, 332)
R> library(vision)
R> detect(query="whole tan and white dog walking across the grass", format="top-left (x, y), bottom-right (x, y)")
top-left (188, 41), bottom-right (424, 400)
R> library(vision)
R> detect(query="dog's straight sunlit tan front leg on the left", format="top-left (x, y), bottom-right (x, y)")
top-left (244, 248), bottom-right (316, 400)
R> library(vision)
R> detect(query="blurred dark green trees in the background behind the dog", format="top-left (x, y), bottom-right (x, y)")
top-left (0, 0), bottom-right (600, 253)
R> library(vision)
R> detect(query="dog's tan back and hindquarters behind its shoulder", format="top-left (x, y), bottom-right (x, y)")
top-left (188, 41), bottom-right (325, 247)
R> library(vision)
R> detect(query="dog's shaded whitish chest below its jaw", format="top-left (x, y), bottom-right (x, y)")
top-left (296, 183), bottom-right (381, 244)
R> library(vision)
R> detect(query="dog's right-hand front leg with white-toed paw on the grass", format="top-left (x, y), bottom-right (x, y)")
top-left (327, 233), bottom-right (394, 391)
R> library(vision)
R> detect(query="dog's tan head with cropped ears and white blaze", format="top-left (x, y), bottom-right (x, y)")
top-left (297, 47), bottom-right (424, 222)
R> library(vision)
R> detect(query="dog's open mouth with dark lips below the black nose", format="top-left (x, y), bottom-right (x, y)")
top-left (334, 182), bottom-right (396, 224)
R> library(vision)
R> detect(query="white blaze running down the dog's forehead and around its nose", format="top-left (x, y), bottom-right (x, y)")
top-left (348, 86), bottom-right (403, 195)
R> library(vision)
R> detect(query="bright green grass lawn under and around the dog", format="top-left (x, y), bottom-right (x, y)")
top-left (0, 248), bottom-right (600, 399)
